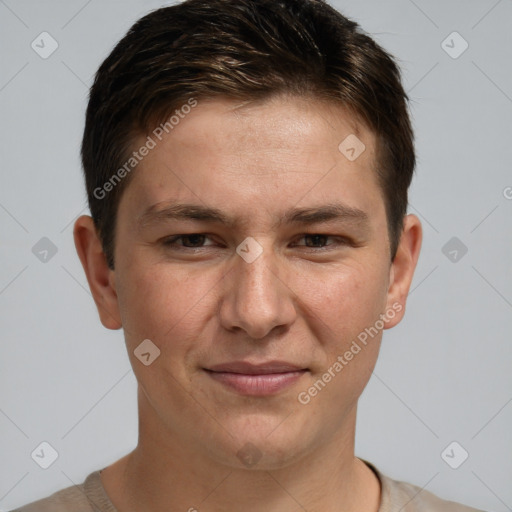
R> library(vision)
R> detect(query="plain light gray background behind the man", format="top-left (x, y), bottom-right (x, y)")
top-left (0, 0), bottom-right (512, 512)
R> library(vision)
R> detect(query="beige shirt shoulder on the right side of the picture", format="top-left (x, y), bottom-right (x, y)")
top-left (363, 461), bottom-right (484, 512)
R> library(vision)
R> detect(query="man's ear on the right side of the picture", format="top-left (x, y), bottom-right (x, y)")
top-left (384, 214), bottom-right (423, 329)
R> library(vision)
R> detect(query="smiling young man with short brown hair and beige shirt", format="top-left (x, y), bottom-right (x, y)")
top-left (11, 0), bottom-right (484, 512)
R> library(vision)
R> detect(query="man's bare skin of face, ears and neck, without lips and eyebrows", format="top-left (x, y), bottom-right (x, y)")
top-left (74, 93), bottom-right (422, 512)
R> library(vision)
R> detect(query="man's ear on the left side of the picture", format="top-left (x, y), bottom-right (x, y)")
top-left (73, 215), bottom-right (122, 329)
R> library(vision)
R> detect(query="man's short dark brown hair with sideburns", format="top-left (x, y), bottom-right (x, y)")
top-left (81, 0), bottom-right (415, 268)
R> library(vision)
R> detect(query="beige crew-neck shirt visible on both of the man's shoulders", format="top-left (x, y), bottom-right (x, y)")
top-left (11, 459), bottom-right (483, 512)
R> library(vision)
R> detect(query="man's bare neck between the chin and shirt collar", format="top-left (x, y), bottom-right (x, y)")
top-left (101, 388), bottom-right (380, 512)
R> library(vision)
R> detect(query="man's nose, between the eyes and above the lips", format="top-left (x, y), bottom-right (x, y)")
top-left (220, 239), bottom-right (296, 340)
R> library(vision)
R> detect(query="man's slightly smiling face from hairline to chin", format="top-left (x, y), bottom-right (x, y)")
top-left (77, 94), bottom-right (415, 468)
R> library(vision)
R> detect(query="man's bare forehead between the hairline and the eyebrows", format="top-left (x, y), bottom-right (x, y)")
top-left (121, 97), bottom-right (380, 230)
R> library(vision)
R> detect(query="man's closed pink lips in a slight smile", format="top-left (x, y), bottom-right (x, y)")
top-left (204, 361), bottom-right (309, 396)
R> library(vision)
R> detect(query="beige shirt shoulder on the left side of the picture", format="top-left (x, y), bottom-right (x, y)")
top-left (11, 470), bottom-right (116, 512)
